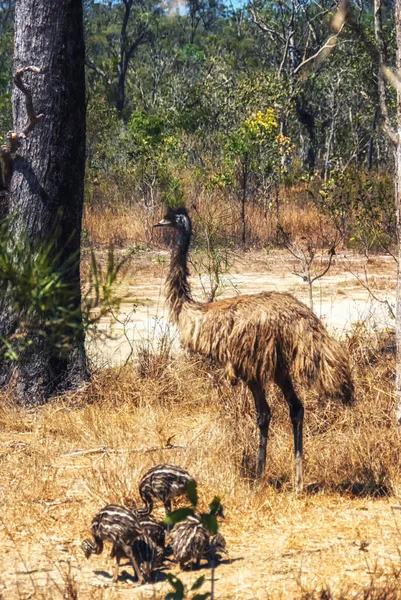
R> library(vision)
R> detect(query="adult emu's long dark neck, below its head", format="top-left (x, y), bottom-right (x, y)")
top-left (167, 226), bottom-right (192, 323)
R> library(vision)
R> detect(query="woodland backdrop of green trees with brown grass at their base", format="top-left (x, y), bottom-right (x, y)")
top-left (0, 0), bottom-right (396, 253)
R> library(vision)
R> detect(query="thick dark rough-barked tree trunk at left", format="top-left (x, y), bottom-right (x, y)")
top-left (0, 0), bottom-right (87, 405)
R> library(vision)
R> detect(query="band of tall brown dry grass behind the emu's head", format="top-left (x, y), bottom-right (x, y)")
top-left (84, 188), bottom-right (334, 248)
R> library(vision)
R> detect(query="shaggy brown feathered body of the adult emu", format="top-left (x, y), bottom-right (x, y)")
top-left (169, 272), bottom-right (353, 403)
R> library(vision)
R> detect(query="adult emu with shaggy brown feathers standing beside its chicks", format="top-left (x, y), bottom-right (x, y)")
top-left (155, 208), bottom-right (353, 491)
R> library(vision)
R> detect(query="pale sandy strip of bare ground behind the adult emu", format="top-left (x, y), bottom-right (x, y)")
top-left (88, 252), bottom-right (396, 367)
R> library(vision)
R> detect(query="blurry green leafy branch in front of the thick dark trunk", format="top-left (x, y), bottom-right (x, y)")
top-left (0, 219), bottom-right (125, 360)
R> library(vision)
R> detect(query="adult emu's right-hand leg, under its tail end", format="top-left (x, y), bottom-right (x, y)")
top-left (276, 374), bottom-right (304, 493)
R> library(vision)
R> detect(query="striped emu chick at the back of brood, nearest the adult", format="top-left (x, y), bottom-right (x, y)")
top-left (139, 465), bottom-right (196, 514)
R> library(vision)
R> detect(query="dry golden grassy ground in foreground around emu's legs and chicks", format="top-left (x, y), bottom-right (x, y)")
top-left (0, 330), bottom-right (401, 600)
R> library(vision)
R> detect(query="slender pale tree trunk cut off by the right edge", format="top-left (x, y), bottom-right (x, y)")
top-left (394, 0), bottom-right (401, 424)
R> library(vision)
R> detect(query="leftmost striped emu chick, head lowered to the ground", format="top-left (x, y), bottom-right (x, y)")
top-left (82, 504), bottom-right (144, 583)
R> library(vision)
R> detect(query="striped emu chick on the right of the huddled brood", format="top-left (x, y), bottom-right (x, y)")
top-left (170, 515), bottom-right (210, 569)
